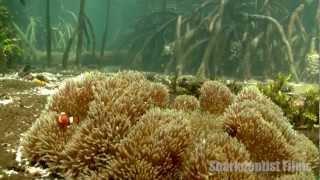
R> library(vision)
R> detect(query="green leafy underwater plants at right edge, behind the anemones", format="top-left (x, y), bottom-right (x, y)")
top-left (258, 74), bottom-right (320, 128)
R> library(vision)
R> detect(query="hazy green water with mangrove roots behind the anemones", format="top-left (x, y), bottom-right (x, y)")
top-left (0, 0), bottom-right (320, 83)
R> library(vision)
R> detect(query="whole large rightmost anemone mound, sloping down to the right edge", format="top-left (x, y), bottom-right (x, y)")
top-left (223, 96), bottom-right (319, 177)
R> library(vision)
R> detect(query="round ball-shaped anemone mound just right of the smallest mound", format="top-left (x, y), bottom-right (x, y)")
top-left (200, 81), bottom-right (234, 114)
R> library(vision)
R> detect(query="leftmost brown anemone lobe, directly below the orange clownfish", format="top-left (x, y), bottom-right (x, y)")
top-left (21, 111), bottom-right (75, 168)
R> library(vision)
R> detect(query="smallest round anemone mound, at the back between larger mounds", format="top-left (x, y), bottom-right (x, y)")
top-left (172, 95), bottom-right (200, 112)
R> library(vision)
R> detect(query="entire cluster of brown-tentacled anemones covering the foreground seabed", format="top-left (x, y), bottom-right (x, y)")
top-left (21, 72), bottom-right (319, 179)
